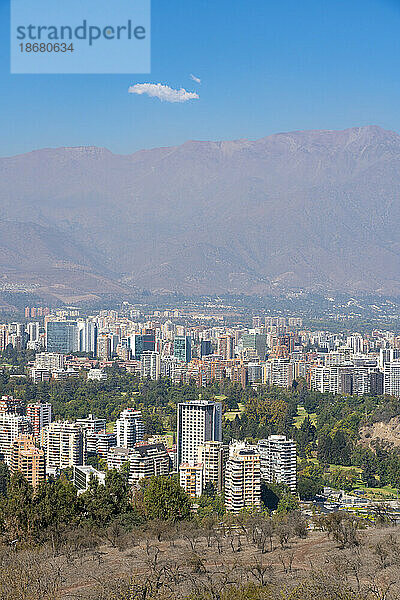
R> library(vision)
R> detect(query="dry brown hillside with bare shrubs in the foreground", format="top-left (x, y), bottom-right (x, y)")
top-left (0, 523), bottom-right (400, 600)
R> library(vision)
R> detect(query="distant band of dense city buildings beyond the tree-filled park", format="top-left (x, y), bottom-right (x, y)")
top-left (0, 307), bottom-right (400, 396)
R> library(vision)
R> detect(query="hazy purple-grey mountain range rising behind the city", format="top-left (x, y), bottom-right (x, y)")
top-left (0, 127), bottom-right (400, 293)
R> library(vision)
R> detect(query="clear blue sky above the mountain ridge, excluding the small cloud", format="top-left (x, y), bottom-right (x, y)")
top-left (0, 0), bottom-right (400, 156)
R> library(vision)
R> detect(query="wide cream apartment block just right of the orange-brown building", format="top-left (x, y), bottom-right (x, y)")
top-left (41, 421), bottom-right (86, 469)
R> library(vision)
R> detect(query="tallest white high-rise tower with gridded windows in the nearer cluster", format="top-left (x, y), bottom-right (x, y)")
top-left (177, 400), bottom-right (222, 465)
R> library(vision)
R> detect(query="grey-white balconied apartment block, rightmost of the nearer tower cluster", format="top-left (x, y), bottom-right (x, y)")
top-left (258, 435), bottom-right (297, 493)
